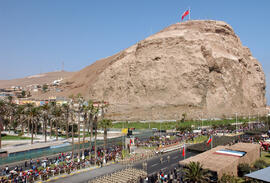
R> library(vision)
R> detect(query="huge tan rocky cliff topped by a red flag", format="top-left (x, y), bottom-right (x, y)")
top-left (62, 20), bottom-right (266, 120)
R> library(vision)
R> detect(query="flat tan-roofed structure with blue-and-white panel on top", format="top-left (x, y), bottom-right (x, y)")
top-left (179, 143), bottom-right (260, 179)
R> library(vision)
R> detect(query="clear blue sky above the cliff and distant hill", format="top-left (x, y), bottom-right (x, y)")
top-left (0, 0), bottom-right (270, 103)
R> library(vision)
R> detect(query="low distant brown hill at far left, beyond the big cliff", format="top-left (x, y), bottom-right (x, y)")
top-left (0, 71), bottom-right (73, 88)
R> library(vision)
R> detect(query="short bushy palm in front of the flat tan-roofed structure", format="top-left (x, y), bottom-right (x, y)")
top-left (183, 161), bottom-right (210, 183)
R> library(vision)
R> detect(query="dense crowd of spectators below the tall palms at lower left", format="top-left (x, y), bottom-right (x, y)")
top-left (0, 145), bottom-right (122, 183)
